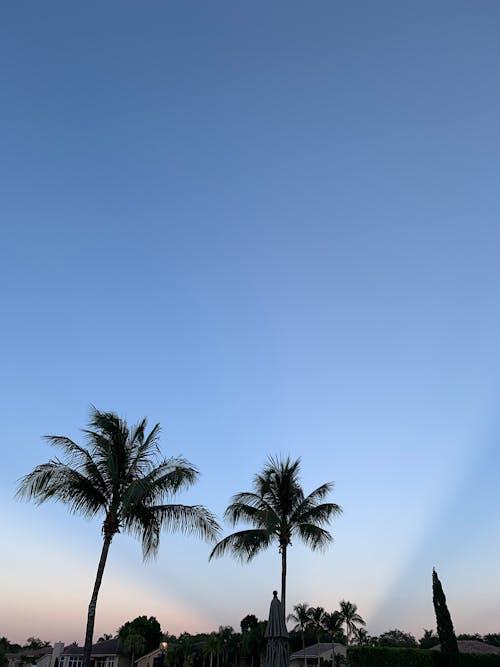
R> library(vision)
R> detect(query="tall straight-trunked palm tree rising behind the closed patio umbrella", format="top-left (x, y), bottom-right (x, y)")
top-left (209, 457), bottom-right (342, 618)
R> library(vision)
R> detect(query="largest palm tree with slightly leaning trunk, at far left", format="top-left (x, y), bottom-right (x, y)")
top-left (16, 408), bottom-right (219, 667)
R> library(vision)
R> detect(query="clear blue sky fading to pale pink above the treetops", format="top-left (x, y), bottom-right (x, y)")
top-left (0, 0), bottom-right (500, 644)
